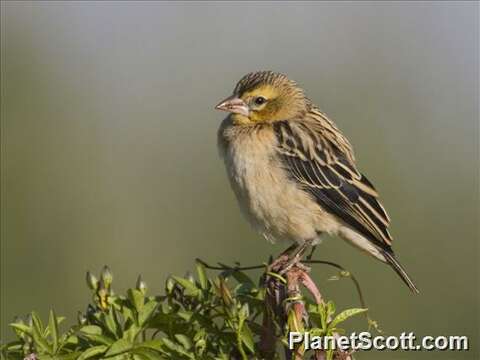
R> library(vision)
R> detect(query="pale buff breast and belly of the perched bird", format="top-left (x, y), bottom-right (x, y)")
top-left (220, 122), bottom-right (339, 244)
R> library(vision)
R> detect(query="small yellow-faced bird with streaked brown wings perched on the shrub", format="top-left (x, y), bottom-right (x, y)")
top-left (215, 71), bottom-right (419, 293)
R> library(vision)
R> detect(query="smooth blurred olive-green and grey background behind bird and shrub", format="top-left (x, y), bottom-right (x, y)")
top-left (1, 1), bottom-right (480, 359)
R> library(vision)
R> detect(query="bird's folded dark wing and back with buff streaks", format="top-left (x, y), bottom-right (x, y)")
top-left (273, 109), bottom-right (392, 252)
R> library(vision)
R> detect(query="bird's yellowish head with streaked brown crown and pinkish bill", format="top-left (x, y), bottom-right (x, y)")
top-left (215, 71), bottom-right (308, 125)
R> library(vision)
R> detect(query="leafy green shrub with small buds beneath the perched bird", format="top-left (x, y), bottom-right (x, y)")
top-left (0, 261), bottom-right (376, 360)
